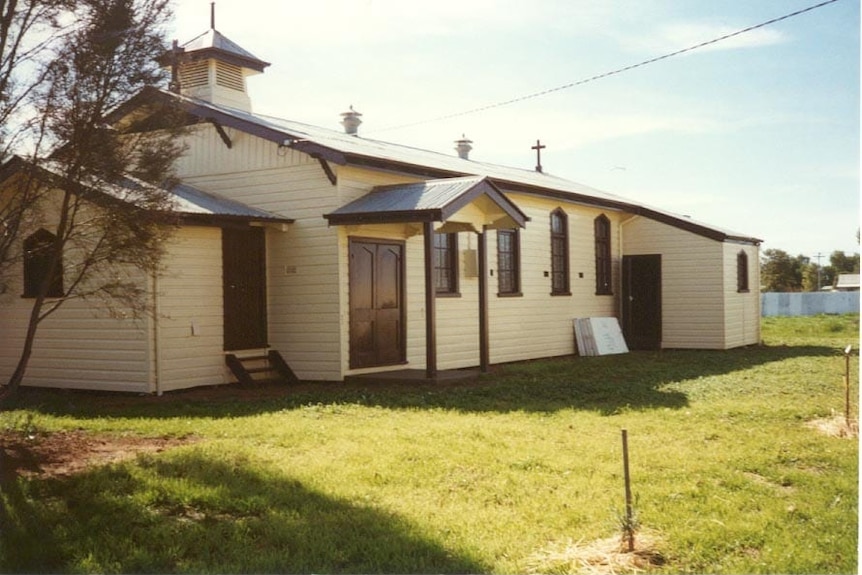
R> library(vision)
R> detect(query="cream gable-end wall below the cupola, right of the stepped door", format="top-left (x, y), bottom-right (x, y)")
top-left (172, 125), bottom-right (348, 380)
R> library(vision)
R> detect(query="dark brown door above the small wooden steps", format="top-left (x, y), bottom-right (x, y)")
top-left (222, 228), bottom-right (267, 351)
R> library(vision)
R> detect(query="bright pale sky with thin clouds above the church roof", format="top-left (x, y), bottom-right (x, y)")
top-left (169, 0), bottom-right (860, 265)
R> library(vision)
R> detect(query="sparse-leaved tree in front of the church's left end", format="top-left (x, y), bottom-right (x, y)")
top-left (0, 0), bottom-right (182, 400)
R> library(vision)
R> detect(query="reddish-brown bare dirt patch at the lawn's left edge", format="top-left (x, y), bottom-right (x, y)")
top-left (0, 431), bottom-right (196, 483)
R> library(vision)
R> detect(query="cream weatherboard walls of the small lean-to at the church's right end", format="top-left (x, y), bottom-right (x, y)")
top-left (621, 216), bottom-right (759, 349)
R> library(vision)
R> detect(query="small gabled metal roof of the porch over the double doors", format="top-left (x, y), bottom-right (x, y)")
top-left (323, 176), bottom-right (529, 227)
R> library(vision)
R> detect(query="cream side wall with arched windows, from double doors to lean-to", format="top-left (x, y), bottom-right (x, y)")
top-left (332, 184), bottom-right (621, 375)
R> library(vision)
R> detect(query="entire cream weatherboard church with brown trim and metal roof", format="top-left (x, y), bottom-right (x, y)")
top-left (0, 25), bottom-right (760, 393)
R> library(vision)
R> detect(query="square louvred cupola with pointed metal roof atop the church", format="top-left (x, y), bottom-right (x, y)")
top-left (161, 7), bottom-right (269, 112)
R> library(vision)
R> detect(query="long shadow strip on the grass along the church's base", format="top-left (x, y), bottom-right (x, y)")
top-left (10, 346), bottom-right (852, 418)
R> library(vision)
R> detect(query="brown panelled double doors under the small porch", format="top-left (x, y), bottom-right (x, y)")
top-left (349, 240), bottom-right (406, 368)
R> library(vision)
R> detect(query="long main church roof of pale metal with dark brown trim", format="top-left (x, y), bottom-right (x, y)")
top-left (109, 89), bottom-right (762, 245)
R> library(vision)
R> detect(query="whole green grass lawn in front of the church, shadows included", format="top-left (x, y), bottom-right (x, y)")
top-left (0, 315), bottom-right (859, 573)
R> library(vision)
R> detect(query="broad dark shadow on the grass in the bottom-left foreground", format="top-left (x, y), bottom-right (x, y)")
top-left (0, 451), bottom-right (487, 573)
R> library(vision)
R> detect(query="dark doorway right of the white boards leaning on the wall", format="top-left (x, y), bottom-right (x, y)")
top-left (623, 255), bottom-right (662, 349)
